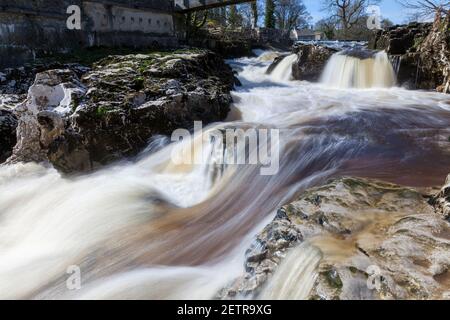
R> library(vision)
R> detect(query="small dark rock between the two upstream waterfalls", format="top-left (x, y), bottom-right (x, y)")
top-left (292, 44), bottom-right (337, 82)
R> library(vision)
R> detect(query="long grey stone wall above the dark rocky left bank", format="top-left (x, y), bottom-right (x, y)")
top-left (0, 0), bottom-right (177, 68)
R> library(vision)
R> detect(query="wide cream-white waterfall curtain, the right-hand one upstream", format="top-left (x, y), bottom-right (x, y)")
top-left (321, 50), bottom-right (397, 89)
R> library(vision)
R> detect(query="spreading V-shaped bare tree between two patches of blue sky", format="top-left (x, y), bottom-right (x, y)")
top-left (323, 0), bottom-right (380, 37)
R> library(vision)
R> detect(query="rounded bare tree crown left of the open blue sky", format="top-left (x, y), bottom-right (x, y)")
top-left (275, 0), bottom-right (311, 30)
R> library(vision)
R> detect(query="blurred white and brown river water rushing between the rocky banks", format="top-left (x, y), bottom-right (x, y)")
top-left (0, 53), bottom-right (450, 299)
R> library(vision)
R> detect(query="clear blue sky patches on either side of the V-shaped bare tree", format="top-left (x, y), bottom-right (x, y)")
top-left (303, 0), bottom-right (407, 23)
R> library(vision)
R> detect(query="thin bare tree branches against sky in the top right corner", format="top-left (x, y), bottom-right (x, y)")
top-left (397, 0), bottom-right (450, 20)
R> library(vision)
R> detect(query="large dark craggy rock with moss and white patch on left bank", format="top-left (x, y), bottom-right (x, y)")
top-left (5, 50), bottom-right (235, 173)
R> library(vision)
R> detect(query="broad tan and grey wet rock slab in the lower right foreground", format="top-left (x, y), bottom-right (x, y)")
top-left (219, 178), bottom-right (450, 300)
